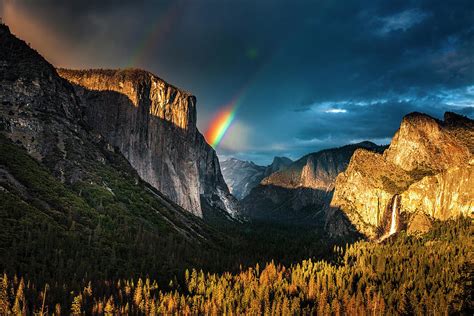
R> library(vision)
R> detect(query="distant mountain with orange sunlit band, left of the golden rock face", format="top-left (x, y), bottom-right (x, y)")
top-left (242, 142), bottom-right (385, 222)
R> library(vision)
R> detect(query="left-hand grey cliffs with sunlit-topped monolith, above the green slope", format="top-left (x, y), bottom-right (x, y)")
top-left (0, 25), bottom-right (236, 220)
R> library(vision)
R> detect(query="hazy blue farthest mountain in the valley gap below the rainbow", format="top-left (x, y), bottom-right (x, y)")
top-left (221, 157), bottom-right (292, 200)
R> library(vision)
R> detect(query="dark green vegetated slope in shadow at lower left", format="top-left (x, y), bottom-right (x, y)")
top-left (0, 136), bottom-right (225, 284)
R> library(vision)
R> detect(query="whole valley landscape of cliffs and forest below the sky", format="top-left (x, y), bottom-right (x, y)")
top-left (0, 16), bottom-right (474, 315)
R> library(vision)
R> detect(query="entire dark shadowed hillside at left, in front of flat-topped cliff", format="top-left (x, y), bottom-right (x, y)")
top-left (0, 23), bottom-right (244, 282)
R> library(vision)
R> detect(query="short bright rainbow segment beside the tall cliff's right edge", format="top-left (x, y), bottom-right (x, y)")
top-left (204, 98), bottom-right (242, 148)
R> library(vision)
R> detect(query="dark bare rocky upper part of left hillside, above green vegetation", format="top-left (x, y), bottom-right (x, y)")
top-left (0, 24), bottom-right (207, 232)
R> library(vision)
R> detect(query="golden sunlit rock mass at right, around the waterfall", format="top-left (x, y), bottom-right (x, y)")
top-left (331, 113), bottom-right (474, 238)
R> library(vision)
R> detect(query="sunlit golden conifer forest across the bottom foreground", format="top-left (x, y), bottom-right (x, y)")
top-left (0, 219), bottom-right (473, 315)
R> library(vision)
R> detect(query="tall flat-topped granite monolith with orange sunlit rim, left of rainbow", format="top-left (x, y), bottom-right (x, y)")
top-left (58, 69), bottom-right (235, 216)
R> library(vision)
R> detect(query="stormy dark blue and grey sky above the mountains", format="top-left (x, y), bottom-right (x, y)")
top-left (0, 0), bottom-right (474, 165)
